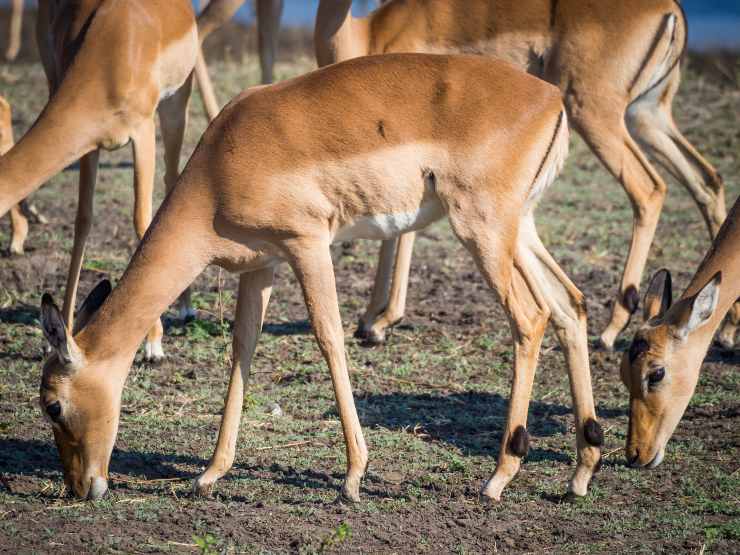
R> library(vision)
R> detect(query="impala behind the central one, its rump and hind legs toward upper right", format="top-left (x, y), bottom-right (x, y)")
top-left (315, 0), bottom-right (740, 348)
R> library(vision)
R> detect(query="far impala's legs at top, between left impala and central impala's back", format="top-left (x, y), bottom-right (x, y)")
top-left (195, 0), bottom-right (283, 120)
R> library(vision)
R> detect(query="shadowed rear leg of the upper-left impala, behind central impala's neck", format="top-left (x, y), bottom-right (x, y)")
top-left (158, 76), bottom-right (196, 322)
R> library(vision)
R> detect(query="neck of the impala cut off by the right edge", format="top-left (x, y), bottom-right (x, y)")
top-left (681, 199), bottom-right (740, 353)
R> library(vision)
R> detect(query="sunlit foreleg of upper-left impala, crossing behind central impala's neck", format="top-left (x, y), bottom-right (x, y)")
top-left (131, 118), bottom-right (164, 360)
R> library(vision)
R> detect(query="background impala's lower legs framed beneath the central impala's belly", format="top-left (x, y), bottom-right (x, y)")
top-left (356, 233), bottom-right (416, 345)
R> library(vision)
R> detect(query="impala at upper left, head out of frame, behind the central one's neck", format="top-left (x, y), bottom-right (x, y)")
top-left (0, 0), bottom-right (198, 358)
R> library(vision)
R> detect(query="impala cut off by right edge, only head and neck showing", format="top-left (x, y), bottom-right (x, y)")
top-left (621, 195), bottom-right (740, 468)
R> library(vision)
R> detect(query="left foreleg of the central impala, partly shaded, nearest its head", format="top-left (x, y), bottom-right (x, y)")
top-left (193, 268), bottom-right (274, 495)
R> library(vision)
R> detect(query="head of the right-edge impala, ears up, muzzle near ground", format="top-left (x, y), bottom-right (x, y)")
top-left (621, 270), bottom-right (722, 468)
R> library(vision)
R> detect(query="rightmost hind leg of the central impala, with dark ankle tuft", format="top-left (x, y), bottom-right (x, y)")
top-left (520, 215), bottom-right (603, 496)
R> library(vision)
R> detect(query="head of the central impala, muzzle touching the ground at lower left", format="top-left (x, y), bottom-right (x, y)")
top-left (40, 281), bottom-right (120, 499)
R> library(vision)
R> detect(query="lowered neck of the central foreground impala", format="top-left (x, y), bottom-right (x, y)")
top-left (75, 176), bottom-right (217, 379)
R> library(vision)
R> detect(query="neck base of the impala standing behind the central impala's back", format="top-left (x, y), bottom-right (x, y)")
top-left (314, 0), bottom-right (370, 67)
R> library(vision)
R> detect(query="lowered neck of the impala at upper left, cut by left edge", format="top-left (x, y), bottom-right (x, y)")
top-left (0, 90), bottom-right (96, 216)
